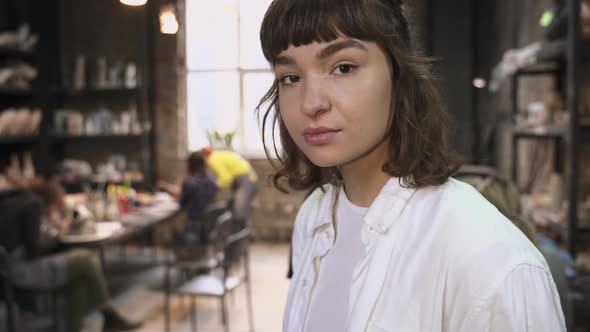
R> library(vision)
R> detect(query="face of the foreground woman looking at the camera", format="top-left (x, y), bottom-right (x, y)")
top-left (274, 37), bottom-right (393, 167)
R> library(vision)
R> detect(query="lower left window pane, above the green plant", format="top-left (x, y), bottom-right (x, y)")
top-left (187, 72), bottom-right (240, 150)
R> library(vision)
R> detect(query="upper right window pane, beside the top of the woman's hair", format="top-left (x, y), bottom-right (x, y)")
top-left (240, 0), bottom-right (271, 69)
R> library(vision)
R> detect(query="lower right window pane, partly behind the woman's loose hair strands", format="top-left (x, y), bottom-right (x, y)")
top-left (242, 72), bottom-right (280, 157)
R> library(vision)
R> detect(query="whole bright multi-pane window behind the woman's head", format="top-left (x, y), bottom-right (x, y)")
top-left (186, 0), bottom-right (274, 157)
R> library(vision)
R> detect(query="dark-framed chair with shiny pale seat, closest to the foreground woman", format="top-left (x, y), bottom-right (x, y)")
top-left (176, 229), bottom-right (254, 332)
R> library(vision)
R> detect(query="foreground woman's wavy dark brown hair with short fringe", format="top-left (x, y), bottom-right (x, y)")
top-left (256, 0), bottom-right (460, 190)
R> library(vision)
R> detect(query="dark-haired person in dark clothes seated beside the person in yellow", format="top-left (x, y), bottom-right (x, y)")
top-left (159, 152), bottom-right (218, 242)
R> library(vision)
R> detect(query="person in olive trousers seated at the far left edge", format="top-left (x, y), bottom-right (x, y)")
top-left (0, 170), bottom-right (141, 332)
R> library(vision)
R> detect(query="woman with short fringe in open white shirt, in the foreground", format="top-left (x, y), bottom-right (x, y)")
top-left (259, 0), bottom-right (565, 332)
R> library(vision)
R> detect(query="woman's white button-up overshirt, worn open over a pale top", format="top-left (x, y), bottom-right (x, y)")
top-left (283, 178), bottom-right (565, 332)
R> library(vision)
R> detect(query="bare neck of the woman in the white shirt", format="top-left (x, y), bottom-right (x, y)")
top-left (340, 142), bottom-right (391, 207)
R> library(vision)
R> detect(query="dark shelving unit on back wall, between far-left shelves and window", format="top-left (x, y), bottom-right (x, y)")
top-left (46, 0), bottom-right (155, 187)
